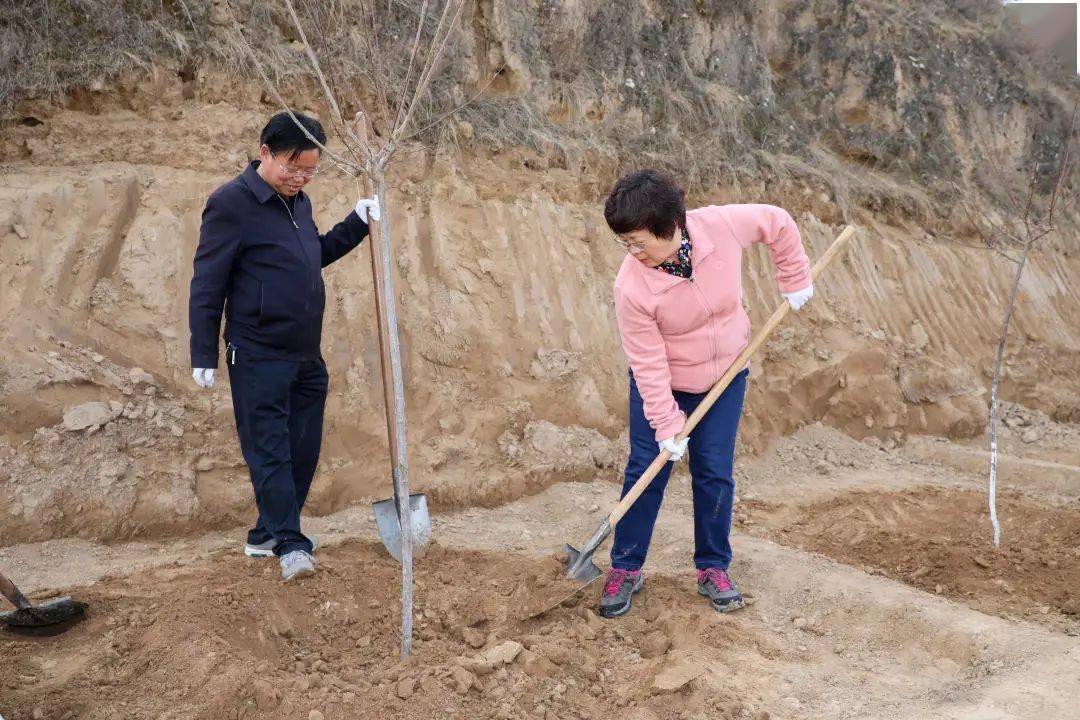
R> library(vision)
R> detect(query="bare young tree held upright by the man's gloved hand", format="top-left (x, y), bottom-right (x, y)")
top-left (230, 0), bottom-right (501, 657)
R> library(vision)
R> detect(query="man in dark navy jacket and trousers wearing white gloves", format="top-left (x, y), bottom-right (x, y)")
top-left (188, 112), bottom-right (379, 581)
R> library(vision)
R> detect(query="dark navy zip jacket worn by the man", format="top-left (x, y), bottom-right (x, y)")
top-left (188, 161), bottom-right (367, 368)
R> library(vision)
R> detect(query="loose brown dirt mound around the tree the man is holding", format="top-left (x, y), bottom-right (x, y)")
top-left (0, 543), bottom-right (758, 720)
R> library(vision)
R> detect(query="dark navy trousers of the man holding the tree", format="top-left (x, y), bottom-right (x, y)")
top-left (226, 345), bottom-right (329, 556)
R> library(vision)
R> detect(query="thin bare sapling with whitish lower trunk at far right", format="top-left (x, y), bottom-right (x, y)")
top-left (958, 104), bottom-right (1080, 547)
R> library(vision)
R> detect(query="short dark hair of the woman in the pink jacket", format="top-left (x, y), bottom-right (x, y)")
top-left (604, 169), bottom-right (686, 237)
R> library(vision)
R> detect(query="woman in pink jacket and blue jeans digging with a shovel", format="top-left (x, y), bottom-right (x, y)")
top-left (599, 171), bottom-right (813, 617)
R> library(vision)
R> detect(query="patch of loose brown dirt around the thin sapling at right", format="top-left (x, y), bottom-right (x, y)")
top-left (757, 488), bottom-right (1080, 631)
